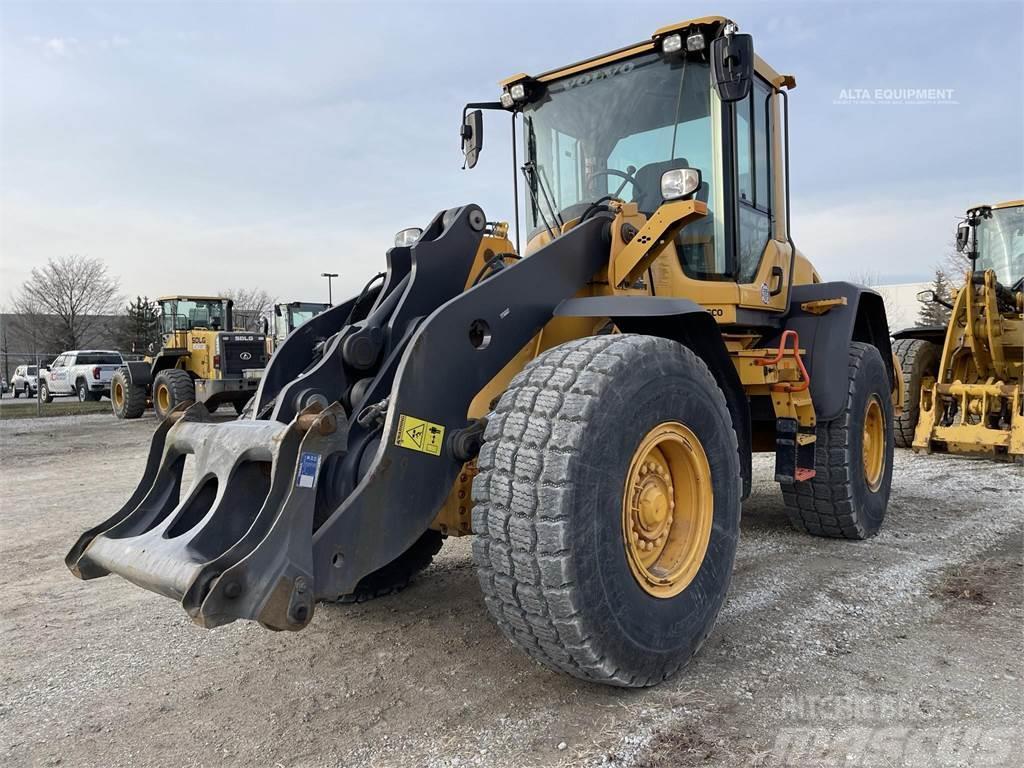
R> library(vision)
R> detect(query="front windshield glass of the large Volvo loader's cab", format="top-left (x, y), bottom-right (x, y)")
top-left (523, 48), bottom-right (724, 262)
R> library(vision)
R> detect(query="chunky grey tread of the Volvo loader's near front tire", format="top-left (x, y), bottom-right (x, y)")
top-left (473, 335), bottom-right (739, 687)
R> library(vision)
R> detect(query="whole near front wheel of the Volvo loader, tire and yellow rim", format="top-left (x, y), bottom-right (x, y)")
top-left (473, 334), bottom-right (741, 687)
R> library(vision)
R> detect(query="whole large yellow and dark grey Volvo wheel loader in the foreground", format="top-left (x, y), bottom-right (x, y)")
top-left (67, 16), bottom-right (899, 686)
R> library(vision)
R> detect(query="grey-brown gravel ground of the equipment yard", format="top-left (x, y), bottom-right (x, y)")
top-left (0, 415), bottom-right (1024, 768)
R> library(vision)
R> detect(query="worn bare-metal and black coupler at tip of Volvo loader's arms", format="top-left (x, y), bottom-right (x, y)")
top-left (66, 404), bottom-right (348, 629)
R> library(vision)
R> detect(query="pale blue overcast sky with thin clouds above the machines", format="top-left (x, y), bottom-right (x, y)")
top-left (0, 0), bottom-right (1024, 302)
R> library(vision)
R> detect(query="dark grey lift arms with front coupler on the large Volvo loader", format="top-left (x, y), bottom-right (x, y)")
top-left (66, 205), bottom-right (609, 630)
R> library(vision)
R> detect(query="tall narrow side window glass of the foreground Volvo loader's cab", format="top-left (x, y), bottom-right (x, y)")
top-left (736, 79), bottom-right (772, 283)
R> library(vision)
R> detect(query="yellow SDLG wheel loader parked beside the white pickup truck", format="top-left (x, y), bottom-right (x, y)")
top-left (111, 296), bottom-right (269, 419)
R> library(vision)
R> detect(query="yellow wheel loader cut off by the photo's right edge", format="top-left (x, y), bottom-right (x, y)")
top-left (893, 200), bottom-right (1024, 462)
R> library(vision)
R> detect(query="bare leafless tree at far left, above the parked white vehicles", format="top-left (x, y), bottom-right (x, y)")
top-left (12, 255), bottom-right (121, 349)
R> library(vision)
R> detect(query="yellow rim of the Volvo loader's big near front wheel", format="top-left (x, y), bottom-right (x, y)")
top-left (623, 421), bottom-right (715, 598)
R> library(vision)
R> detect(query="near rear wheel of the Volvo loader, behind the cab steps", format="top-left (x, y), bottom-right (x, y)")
top-left (781, 341), bottom-right (893, 539)
